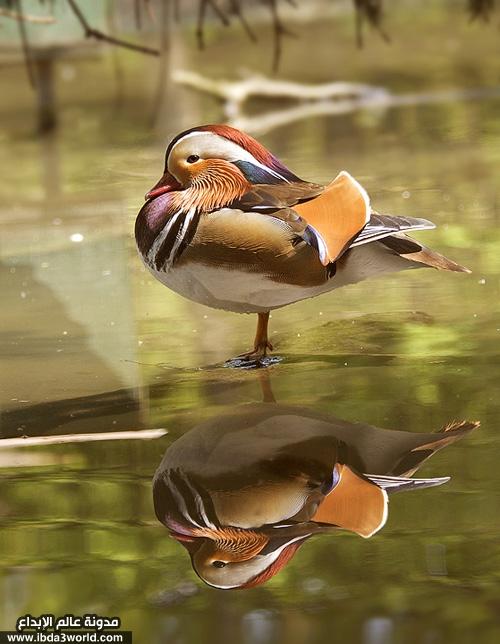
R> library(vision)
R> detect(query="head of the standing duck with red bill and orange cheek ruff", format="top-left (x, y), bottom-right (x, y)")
top-left (146, 125), bottom-right (301, 210)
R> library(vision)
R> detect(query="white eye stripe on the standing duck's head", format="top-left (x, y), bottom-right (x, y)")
top-left (167, 132), bottom-right (290, 183)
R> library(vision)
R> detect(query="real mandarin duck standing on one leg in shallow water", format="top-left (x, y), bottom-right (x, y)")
top-left (135, 125), bottom-right (469, 359)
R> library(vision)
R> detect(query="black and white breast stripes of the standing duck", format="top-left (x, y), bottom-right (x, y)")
top-left (146, 208), bottom-right (200, 271)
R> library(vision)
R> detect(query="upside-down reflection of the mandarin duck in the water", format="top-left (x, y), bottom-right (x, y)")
top-left (153, 374), bottom-right (479, 589)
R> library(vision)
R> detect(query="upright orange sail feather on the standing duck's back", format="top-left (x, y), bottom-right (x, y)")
top-left (294, 172), bottom-right (371, 266)
